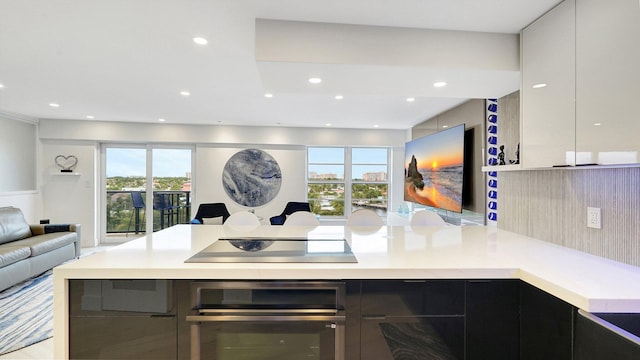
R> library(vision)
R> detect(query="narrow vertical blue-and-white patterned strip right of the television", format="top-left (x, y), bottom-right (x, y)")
top-left (485, 99), bottom-right (500, 226)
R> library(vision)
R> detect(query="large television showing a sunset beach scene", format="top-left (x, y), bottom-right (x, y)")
top-left (404, 124), bottom-right (465, 213)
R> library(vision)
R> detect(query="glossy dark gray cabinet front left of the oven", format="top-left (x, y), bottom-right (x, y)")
top-left (69, 280), bottom-right (177, 359)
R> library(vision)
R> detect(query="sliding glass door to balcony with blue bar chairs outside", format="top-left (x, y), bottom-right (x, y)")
top-left (101, 145), bottom-right (192, 243)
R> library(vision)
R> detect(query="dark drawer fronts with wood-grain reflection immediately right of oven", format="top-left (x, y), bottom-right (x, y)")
top-left (360, 280), bottom-right (465, 360)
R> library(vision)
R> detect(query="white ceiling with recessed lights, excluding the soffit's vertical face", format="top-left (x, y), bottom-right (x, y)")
top-left (0, 0), bottom-right (560, 129)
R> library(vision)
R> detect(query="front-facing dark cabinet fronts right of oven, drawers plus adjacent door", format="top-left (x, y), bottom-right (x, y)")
top-left (359, 280), bottom-right (520, 360)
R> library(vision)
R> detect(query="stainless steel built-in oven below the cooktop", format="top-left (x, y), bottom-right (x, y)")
top-left (187, 281), bottom-right (345, 360)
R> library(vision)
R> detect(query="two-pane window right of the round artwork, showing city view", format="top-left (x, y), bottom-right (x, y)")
top-left (307, 147), bottom-right (389, 217)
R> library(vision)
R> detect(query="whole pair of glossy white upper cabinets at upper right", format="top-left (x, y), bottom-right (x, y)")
top-left (520, 0), bottom-right (640, 169)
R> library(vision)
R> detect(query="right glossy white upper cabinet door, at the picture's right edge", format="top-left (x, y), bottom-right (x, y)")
top-left (576, 0), bottom-right (640, 165)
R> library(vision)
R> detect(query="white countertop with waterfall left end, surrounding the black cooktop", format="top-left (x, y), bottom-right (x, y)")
top-left (54, 225), bottom-right (640, 358)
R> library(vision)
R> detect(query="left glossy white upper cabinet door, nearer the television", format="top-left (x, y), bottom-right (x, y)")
top-left (520, 0), bottom-right (576, 168)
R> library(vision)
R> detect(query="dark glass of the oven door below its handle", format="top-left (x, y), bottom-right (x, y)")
top-left (192, 321), bottom-right (339, 360)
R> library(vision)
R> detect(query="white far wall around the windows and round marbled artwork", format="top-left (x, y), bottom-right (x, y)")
top-left (39, 120), bottom-right (408, 247)
